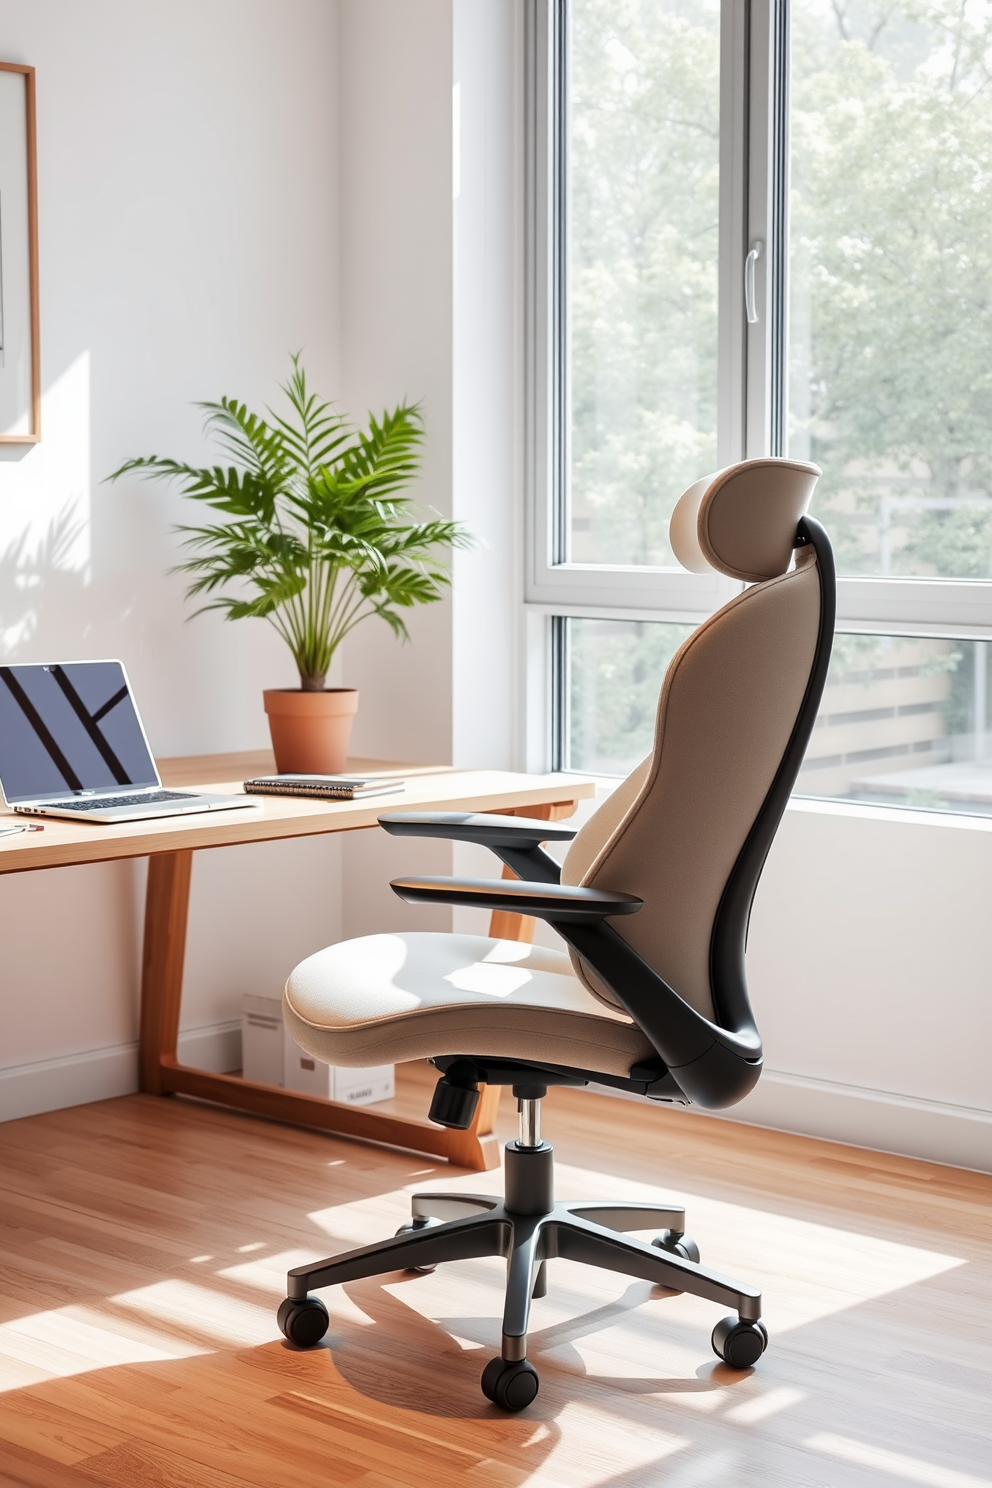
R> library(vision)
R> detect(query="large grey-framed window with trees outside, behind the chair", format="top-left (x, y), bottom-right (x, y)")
top-left (526, 0), bottom-right (992, 812)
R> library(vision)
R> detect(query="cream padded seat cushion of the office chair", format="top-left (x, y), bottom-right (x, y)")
top-left (283, 931), bottom-right (654, 1076)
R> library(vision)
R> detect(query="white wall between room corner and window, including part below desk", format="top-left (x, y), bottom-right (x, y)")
top-left (333, 0), bottom-right (522, 934)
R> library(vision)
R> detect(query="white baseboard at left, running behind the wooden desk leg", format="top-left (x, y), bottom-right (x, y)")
top-left (0, 1018), bottom-right (241, 1122)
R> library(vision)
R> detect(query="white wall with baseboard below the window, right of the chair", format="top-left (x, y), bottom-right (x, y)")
top-left (740, 802), bottom-right (992, 1170)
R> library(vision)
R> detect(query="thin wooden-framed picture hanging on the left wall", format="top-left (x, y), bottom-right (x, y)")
top-left (0, 62), bottom-right (42, 445)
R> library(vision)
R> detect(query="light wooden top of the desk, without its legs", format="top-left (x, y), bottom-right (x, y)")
top-left (0, 753), bottom-right (596, 873)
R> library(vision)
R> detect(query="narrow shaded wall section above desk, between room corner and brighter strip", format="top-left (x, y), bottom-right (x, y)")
top-left (341, 0), bottom-right (452, 763)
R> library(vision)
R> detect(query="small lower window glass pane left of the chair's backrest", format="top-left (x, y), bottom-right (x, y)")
top-left (564, 619), bottom-right (693, 775)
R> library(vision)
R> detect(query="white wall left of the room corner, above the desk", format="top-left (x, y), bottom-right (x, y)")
top-left (0, 0), bottom-right (341, 754)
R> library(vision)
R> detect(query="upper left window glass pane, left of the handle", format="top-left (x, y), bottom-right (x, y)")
top-left (565, 0), bottom-right (720, 565)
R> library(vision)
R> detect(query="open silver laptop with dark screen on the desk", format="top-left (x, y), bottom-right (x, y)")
top-left (0, 661), bottom-right (260, 821)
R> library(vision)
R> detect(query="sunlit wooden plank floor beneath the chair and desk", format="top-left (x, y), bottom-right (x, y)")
top-left (0, 1092), bottom-right (992, 1488)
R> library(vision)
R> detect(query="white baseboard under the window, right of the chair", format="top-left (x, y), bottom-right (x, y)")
top-left (593, 1070), bottom-right (992, 1173)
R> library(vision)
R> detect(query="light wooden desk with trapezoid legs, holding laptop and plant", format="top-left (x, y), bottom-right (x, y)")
top-left (0, 753), bottom-right (595, 1168)
